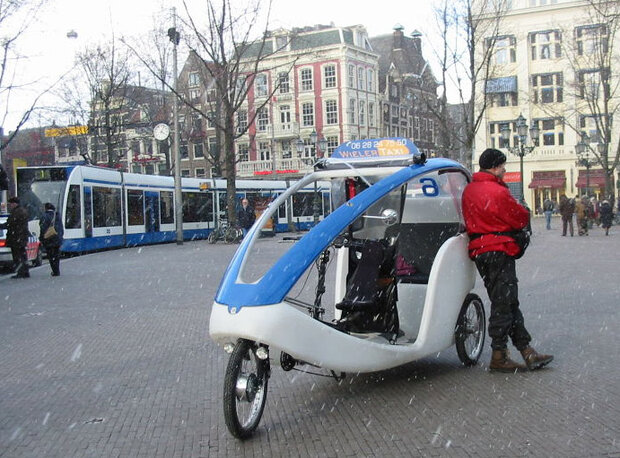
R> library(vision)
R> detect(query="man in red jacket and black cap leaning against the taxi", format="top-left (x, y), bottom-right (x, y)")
top-left (463, 148), bottom-right (553, 372)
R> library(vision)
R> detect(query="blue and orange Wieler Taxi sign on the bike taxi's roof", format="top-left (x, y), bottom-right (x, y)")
top-left (331, 137), bottom-right (420, 161)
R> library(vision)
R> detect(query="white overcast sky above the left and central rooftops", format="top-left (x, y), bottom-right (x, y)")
top-left (0, 0), bottom-right (433, 132)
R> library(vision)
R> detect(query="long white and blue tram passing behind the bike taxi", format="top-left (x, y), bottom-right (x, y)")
top-left (17, 165), bottom-right (329, 253)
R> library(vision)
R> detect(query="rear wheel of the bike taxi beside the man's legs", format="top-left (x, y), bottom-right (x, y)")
top-left (455, 294), bottom-right (486, 366)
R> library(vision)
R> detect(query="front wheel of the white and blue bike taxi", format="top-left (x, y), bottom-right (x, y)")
top-left (224, 339), bottom-right (269, 439)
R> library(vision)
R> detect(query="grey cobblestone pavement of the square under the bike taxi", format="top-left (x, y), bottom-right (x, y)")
top-left (0, 219), bottom-right (620, 457)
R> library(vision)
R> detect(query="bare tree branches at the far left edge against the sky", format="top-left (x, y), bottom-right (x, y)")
top-left (0, 0), bottom-right (53, 151)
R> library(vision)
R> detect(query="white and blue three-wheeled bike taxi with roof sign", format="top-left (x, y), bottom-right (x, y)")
top-left (209, 138), bottom-right (485, 438)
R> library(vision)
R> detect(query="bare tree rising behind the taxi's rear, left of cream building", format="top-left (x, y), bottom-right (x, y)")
top-left (427, 0), bottom-right (507, 167)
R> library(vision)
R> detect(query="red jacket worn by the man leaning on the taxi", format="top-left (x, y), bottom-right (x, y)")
top-left (463, 172), bottom-right (530, 259)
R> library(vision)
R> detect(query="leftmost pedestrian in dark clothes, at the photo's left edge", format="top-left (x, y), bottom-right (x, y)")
top-left (0, 197), bottom-right (30, 278)
